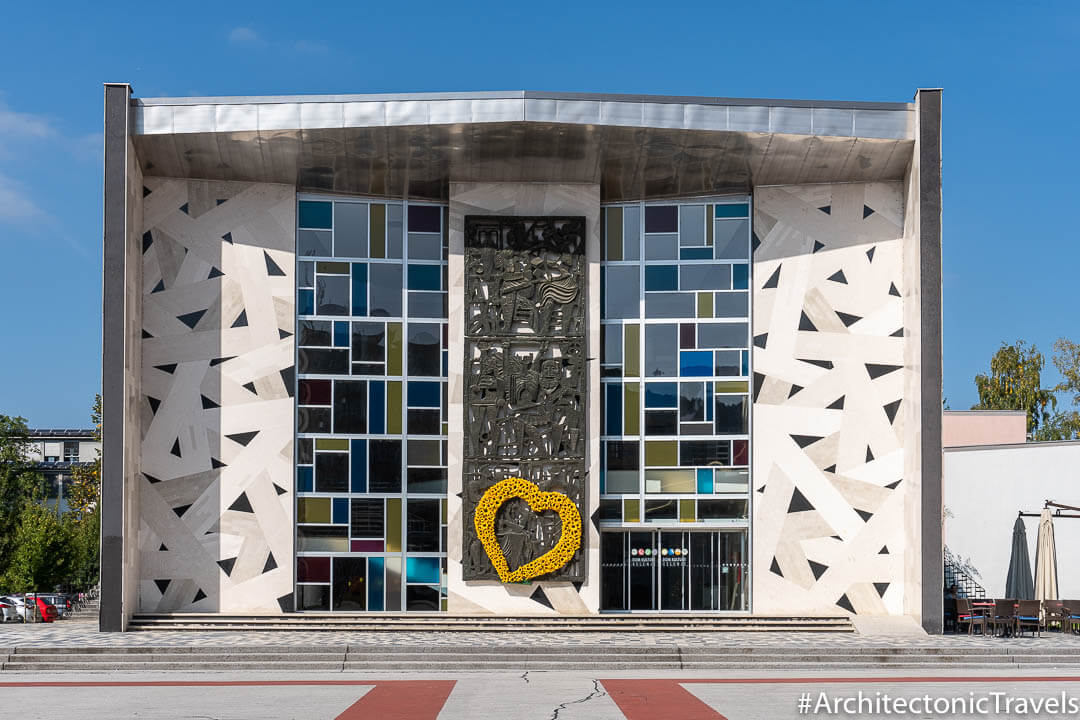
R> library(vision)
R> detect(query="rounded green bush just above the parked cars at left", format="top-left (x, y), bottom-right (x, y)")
top-left (0, 503), bottom-right (72, 593)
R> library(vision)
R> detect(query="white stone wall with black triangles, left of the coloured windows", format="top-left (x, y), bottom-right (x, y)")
top-left (138, 177), bottom-right (295, 612)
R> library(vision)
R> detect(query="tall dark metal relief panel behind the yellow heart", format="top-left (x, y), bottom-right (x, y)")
top-left (462, 215), bottom-right (588, 581)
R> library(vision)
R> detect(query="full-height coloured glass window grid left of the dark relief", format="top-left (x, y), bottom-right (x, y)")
top-left (296, 196), bottom-right (448, 611)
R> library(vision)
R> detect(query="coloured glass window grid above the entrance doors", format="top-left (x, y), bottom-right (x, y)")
top-left (600, 196), bottom-right (752, 527)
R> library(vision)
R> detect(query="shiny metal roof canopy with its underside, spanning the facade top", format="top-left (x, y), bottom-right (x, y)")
top-left (132, 92), bottom-right (915, 202)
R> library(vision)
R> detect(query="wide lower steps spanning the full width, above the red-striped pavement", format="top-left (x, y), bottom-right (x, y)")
top-left (0, 642), bottom-right (1080, 677)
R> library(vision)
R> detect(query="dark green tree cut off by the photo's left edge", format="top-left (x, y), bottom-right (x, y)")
top-left (0, 415), bottom-right (43, 575)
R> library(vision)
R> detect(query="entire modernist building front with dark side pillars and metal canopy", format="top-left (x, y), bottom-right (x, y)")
top-left (102, 84), bottom-right (942, 629)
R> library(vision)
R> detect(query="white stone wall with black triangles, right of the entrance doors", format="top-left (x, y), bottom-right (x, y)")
top-left (753, 184), bottom-right (917, 614)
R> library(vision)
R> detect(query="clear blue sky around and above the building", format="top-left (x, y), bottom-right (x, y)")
top-left (0, 0), bottom-right (1080, 426)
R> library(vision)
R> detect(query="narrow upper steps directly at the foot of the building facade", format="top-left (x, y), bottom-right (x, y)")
top-left (129, 613), bottom-right (854, 633)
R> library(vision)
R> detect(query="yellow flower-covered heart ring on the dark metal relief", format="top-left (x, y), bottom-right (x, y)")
top-left (473, 477), bottom-right (581, 583)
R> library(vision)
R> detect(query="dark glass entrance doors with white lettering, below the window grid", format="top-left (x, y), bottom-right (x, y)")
top-left (600, 530), bottom-right (747, 612)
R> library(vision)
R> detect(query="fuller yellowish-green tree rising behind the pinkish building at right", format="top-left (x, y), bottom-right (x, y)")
top-left (971, 340), bottom-right (1057, 436)
